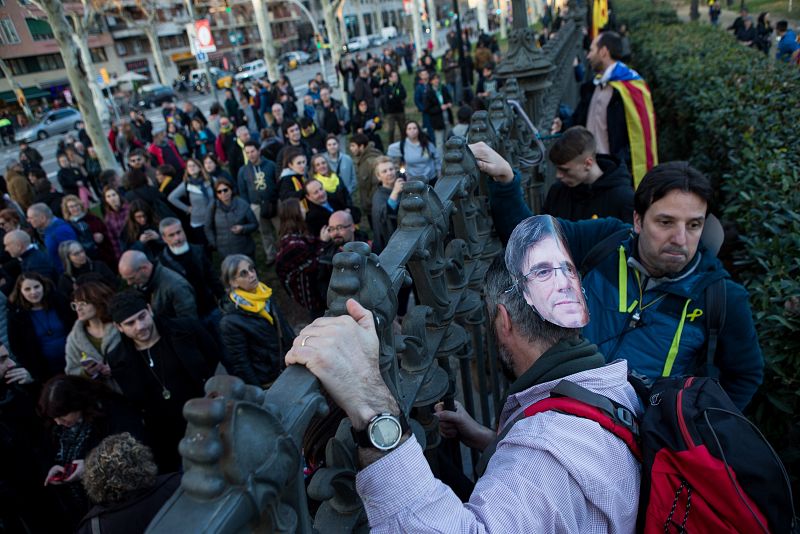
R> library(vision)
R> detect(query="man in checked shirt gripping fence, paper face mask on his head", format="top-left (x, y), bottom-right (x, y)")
top-left (286, 249), bottom-right (640, 533)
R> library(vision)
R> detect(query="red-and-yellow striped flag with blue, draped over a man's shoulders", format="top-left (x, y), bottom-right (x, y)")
top-left (600, 62), bottom-right (658, 188)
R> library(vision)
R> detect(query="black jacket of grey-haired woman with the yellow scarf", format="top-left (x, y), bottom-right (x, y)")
top-left (220, 295), bottom-right (294, 386)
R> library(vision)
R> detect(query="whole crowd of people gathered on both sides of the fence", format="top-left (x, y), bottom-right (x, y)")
top-left (0, 17), bottom-right (776, 532)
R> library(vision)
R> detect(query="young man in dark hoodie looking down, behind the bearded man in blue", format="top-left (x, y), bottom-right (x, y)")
top-left (543, 126), bottom-right (633, 224)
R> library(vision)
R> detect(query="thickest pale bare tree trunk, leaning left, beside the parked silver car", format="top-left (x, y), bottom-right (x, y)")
top-left (35, 0), bottom-right (121, 172)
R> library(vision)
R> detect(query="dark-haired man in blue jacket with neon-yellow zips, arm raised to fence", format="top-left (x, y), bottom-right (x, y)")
top-left (471, 143), bottom-right (764, 409)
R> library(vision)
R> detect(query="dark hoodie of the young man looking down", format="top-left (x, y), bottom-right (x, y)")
top-left (542, 154), bottom-right (633, 224)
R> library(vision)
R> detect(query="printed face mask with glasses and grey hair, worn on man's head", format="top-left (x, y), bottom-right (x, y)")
top-left (505, 215), bottom-right (589, 328)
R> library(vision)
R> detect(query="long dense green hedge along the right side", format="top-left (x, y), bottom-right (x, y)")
top-left (614, 0), bottom-right (800, 484)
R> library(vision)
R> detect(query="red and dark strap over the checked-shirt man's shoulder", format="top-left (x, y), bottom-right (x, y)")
top-left (524, 380), bottom-right (642, 462)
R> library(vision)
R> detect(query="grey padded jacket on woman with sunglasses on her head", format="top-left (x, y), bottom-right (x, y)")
top-left (203, 197), bottom-right (258, 258)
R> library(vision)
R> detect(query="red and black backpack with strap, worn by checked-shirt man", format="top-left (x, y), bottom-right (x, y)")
top-left (525, 377), bottom-right (798, 534)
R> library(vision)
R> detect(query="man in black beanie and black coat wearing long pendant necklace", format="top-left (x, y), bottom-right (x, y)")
top-left (108, 290), bottom-right (220, 473)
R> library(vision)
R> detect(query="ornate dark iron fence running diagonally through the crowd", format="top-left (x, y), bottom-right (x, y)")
top-left (148, 9), bottom-right (583, 533)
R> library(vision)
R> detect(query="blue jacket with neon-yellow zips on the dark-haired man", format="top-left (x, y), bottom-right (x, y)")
top-left (489, 176), bottom-right (764, 409)
